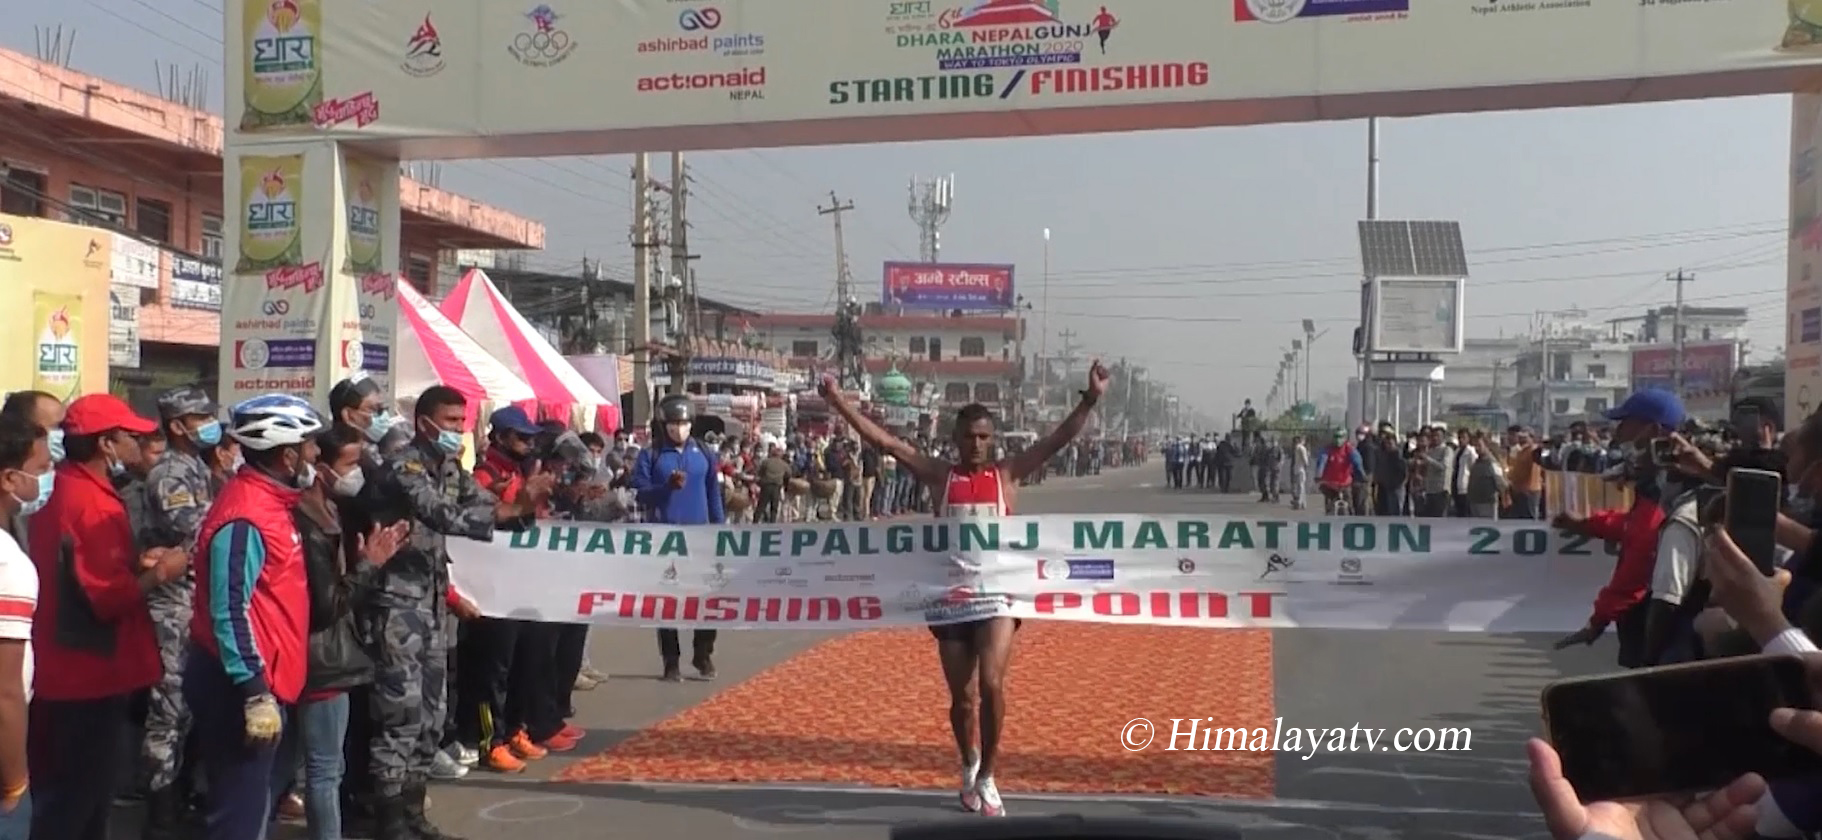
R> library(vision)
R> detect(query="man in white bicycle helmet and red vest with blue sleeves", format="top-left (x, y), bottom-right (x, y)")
top-left (184, 394), bottom-right (324, 840)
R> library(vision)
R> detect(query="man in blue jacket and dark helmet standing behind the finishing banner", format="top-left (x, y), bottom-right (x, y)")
top-left (632, 394), bottom-right (727, 683)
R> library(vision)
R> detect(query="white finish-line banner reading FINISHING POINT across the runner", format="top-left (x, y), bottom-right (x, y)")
top-left (450, 516), bottom-right (1612, 632)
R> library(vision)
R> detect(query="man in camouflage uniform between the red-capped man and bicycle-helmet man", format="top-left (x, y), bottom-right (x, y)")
top-left (140, 386), bottom-right (222, 827)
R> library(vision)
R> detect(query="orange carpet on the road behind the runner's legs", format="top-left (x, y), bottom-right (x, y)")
top-left (559, 621), bottom-right (1272, 798)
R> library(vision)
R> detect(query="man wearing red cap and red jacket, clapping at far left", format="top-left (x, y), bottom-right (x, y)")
top-left (27, 394), bottom-right (189, 840)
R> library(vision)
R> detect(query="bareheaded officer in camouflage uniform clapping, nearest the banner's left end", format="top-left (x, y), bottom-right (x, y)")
top-left (361, 384), bottom-right (552, 840)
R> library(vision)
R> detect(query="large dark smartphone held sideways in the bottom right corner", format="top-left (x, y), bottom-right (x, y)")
top-left (1541, 656), bottom-right (1822, 802)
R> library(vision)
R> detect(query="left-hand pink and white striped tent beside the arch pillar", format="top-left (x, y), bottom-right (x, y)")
top-left (392, 279), bottom-right (536, 428)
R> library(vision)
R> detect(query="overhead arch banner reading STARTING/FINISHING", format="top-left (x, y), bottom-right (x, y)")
top-left (226, 0), bottom-right (1822, 157)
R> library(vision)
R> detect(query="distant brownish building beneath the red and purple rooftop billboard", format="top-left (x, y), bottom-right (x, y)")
top-left (734, 313), bottom-right (1022, 412)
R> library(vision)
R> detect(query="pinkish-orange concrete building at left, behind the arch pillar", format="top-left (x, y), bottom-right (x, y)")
top-left (0, 49), bottom-right (545, 397)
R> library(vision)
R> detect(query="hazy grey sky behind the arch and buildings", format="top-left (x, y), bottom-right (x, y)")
top-left (0, 0), bottom-right (1789, 415)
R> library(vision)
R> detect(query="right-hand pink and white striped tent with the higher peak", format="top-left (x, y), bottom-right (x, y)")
top-left (439, 268), bottom-right (619, 432)
